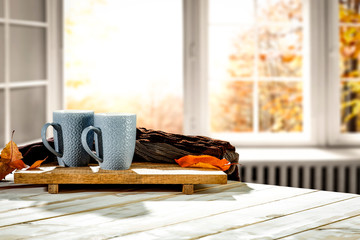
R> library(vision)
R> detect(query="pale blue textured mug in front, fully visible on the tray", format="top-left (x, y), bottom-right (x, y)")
top-left (81, 113), bottom-right (136, 170)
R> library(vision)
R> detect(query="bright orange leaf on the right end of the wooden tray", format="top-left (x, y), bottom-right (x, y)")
top-left (175, 155), bottom-right (231, 171)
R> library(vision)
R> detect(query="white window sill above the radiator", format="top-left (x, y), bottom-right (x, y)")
top-left (236, 148), bottom-right (360, 164)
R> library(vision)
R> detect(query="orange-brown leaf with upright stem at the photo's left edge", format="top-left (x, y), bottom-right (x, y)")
top-left (0, 131), bottom-right (26, 180)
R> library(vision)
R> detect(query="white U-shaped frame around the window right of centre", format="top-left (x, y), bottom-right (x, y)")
top-left (184, 0), bottom-right (326, 146)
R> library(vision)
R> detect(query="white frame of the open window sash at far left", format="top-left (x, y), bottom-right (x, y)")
top-left (0, 0), bottom-right (63, 145)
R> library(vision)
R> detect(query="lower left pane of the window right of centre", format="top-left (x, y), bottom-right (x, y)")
top-left (210, 81), bottom-right (253, 132)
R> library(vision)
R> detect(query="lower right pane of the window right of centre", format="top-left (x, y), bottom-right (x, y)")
top-left (259, 81), bottom-right (303, 132)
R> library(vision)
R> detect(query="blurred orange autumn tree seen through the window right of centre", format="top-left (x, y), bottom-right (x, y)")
top-left (210, 0), bottom-right (303, 132)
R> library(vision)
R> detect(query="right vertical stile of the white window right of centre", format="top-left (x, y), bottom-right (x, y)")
top-left (303, 0), bottom-right (329, 146)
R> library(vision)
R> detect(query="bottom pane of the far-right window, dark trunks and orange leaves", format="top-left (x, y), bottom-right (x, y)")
top-left (341, 81), bottom-right (360, 133)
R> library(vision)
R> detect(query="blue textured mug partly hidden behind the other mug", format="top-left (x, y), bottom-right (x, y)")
top-left (41, 110), bottom-right (94, 167)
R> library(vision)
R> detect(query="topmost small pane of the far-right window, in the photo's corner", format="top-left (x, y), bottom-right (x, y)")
top-left (339, 0), bottom-right (360, 23)
